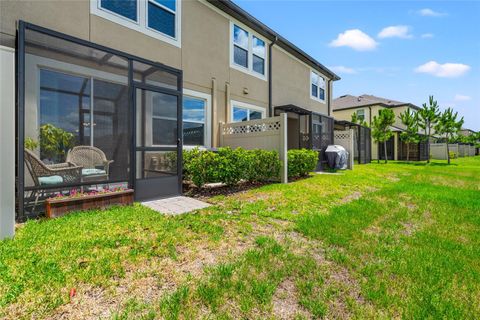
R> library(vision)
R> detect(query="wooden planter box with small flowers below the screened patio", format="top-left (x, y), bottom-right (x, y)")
top-left (45, 188), bottom-right (133, 218)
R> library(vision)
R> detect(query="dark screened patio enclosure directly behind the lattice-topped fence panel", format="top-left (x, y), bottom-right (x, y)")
top-left (275, 105), bottom-right (334, 170)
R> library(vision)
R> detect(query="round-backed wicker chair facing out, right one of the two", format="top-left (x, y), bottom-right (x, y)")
top-left (67, 146), bottom-right (113, 181)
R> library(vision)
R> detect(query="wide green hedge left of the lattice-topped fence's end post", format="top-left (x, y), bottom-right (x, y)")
top-left (183, 147), bottom-right (280, 187)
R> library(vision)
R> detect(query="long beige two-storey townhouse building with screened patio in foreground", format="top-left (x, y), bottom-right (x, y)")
top-left (0, 0), bottom-right (339, 220)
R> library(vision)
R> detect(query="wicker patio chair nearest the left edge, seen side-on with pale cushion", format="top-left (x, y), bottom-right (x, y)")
top-left (24, 149), bottom-right (82, 211)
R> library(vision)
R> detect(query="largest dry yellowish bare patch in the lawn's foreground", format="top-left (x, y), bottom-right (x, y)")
top-left (44, 225), bottom-right (262, 319)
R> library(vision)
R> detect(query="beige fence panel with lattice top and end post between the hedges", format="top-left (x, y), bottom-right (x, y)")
top-left (220, 113), bottom-right (288, 183)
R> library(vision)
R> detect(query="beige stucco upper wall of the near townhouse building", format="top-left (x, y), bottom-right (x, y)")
top-left (0, 0), bottom-right (332, 148)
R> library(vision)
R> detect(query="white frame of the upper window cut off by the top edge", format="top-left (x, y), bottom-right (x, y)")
top-left (90, 0), bottom-right (182, 48)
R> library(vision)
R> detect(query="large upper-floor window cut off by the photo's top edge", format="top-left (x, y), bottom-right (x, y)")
top-left (90, 0), bottom-right (181, 47)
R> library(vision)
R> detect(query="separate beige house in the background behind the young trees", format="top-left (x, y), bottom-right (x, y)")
top-left (332, 94), bottom-right (428, 160)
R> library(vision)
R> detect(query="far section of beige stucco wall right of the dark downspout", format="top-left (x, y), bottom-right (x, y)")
top-left (272, 47), bottom-right (331, 115)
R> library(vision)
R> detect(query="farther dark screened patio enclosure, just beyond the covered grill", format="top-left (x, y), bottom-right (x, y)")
top-left (335, 120), bottom-right (372, 164)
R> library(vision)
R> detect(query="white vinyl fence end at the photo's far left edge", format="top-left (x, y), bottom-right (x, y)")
top-left (0, 46), bottom-right (15, 240)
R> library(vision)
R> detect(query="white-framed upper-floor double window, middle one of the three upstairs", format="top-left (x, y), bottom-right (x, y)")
top-left (231, 23), bottom-right (267, 79)
